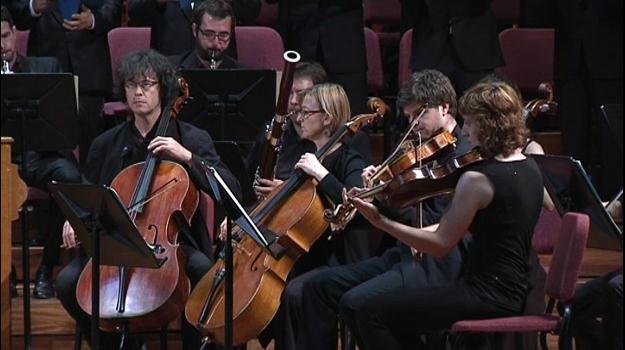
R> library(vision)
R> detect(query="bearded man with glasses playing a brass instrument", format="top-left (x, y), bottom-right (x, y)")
top-left (169, 0), bottom-right (241, 69)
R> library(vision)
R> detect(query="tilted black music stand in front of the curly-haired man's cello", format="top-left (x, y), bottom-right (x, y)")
top-left (48, 182), bottom-right (165, 349)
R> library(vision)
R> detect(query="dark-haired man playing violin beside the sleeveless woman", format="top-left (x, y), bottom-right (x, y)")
top-left (276, 70), bottom-right (471, 350)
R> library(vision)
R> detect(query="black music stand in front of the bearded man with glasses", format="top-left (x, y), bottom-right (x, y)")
top-left (179, 69), bottom-right (276, 144)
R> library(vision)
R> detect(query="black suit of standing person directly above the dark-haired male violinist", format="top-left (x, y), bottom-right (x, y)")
top-left (411, 0), bottom-right (503, 71)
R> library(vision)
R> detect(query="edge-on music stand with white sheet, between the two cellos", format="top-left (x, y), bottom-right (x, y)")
top-left (200, 162), bottom-right (277, 350)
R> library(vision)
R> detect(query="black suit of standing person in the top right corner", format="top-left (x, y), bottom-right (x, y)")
top-left (554, 0), bottom-right (623, 79)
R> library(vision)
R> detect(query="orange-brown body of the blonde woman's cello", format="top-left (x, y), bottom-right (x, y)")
top-left (185, 180), bottom-right (328, 345)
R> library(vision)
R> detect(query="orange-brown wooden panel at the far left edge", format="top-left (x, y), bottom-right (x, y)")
top-left (0, 137), bottom-right (26, 350)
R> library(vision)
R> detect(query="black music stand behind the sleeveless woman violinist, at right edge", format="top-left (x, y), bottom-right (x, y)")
top-left (532, 155), bottom-right (623, 250)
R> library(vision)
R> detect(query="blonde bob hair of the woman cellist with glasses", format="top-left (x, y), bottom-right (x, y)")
top-left (306, 83), bottom-right (352, 134)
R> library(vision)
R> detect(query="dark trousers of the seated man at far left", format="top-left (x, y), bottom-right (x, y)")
top-left (15, 151), bottom-right (81, 268)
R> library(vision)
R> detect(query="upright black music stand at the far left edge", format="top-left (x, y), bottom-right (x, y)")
top-left (0, 73), bottom-right (78, 349)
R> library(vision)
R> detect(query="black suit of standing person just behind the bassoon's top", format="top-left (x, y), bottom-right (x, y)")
top-left (267, 0), bottom-right (367, 73)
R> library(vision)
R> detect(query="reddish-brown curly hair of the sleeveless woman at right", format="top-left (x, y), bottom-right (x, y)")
top-left (459, 81), bottom-right (529, 158)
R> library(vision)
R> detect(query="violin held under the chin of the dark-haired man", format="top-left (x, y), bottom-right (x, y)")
top-left (323, 130), bottom-right (457, 231)
